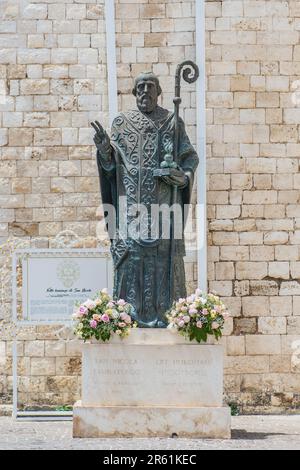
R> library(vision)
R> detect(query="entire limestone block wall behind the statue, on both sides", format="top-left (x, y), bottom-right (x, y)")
top-left (0, 0), bottom-right (300, 412)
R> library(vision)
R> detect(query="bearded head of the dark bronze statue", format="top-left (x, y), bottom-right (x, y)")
top-left (132, 72), bottom-right (161, 114)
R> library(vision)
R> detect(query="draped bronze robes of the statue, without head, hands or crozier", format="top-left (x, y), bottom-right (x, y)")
top-left (97, 107), bottom-right (198, 327)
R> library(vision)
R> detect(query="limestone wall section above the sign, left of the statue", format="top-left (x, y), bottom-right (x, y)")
top-left (0, 0), bottom-right (106, 240)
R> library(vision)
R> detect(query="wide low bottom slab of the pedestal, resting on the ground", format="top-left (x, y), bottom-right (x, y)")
top-left (73, 402), bottom-right (230, 439)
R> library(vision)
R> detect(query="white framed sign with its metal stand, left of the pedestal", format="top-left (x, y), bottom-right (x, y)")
top-left (12, 248), bottom-right (113, 420)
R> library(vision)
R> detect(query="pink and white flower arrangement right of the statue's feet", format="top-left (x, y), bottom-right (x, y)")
top-left (166, 289), bottom-right (230, 343)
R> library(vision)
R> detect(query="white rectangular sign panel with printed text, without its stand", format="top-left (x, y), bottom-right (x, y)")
top-left (22, 250), bottom-right (112, 321)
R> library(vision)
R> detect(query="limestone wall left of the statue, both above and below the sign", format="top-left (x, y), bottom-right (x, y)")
top-left (0, 0), bottom-right (107, 412)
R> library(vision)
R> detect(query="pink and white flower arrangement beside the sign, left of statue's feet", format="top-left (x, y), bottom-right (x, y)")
top-left (73, 289), bottom-right (136, 341)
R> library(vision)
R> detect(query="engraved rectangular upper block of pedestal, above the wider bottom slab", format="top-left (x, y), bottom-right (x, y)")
top-left (82, 344), bottom-right (223, 407)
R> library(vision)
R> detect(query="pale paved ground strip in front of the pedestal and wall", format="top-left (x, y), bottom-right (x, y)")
top-left (0, 415), bottom-right (300, 450)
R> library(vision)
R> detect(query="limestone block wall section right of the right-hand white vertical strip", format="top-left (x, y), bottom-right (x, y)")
top-left (206, 0), bottom-right (300, 411)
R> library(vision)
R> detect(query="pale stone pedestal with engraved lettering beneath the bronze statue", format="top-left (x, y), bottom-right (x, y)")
top-left (73, 329), bottom-right (230, 438)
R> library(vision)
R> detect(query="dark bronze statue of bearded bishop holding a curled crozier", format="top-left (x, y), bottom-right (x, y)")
top-left (92, 61), bottom-right (198, 328)
